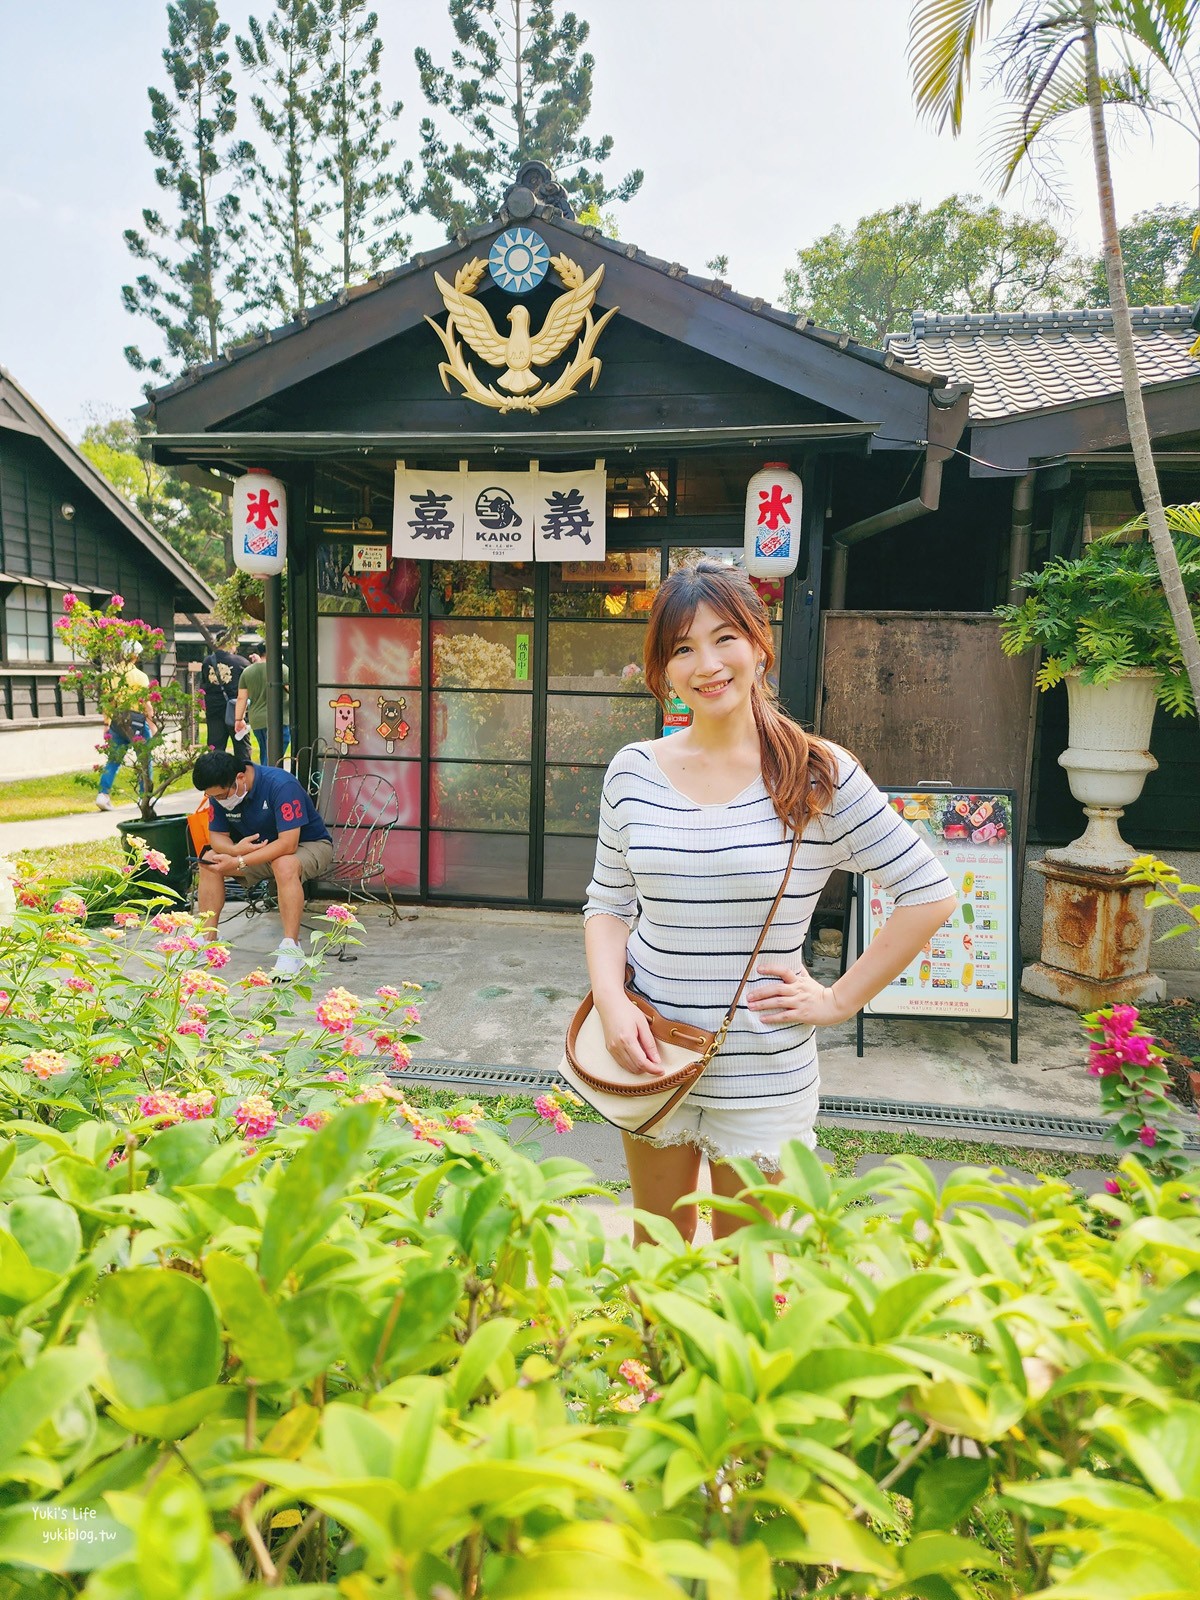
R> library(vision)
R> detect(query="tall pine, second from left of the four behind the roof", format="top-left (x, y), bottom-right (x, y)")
top-left (237, 0), bottom-right (330, 320)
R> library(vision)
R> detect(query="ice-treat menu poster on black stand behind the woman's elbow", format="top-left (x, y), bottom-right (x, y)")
top-left (859, 789), bottom-right (1016, 1021)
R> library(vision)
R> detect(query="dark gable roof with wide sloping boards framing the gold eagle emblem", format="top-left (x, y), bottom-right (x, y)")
top-left (141, 206), bottom-right (962, 448)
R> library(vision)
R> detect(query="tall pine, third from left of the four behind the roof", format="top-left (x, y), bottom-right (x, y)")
top-left (320, 0), bottom-right (413, 288)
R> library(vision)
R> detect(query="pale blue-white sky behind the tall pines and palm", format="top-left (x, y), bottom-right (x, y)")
top-left (0, 0), bottom-right (1197, 435)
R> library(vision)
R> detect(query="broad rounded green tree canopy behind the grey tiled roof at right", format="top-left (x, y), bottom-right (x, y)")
top-left (784, 195), bottom-right (1082, 346)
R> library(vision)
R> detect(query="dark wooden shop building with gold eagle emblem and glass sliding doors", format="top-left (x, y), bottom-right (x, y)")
top-left (149, 166), bottom-right (1200, 907)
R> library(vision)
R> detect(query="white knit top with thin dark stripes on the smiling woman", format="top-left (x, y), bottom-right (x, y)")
top-left (584, 741), bottom-right (954, 1109)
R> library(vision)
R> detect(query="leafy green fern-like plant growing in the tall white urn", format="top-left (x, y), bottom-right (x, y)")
top-left (995, 502), bottom-right (1200, 717)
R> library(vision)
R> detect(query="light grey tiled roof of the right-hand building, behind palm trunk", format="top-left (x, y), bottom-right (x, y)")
top-left (883, 306), bottom-right (1200, 422)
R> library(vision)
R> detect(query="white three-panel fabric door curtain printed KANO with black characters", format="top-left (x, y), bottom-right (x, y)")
top-left (392, 461), bottom-right (606, 563)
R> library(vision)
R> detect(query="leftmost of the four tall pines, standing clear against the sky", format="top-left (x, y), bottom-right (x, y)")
top-left (122, 0), bottom-right (250, 378)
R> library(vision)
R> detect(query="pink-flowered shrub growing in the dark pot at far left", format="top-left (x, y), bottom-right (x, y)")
top-left (54, 594), bottom-right (200, 825)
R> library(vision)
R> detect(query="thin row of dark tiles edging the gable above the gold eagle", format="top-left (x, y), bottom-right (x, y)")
top-left (145, 206), bottom-right (946, 414)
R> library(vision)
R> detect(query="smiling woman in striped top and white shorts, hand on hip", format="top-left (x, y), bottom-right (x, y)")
top-left (584, 562), bottom-right (955, 1240)
